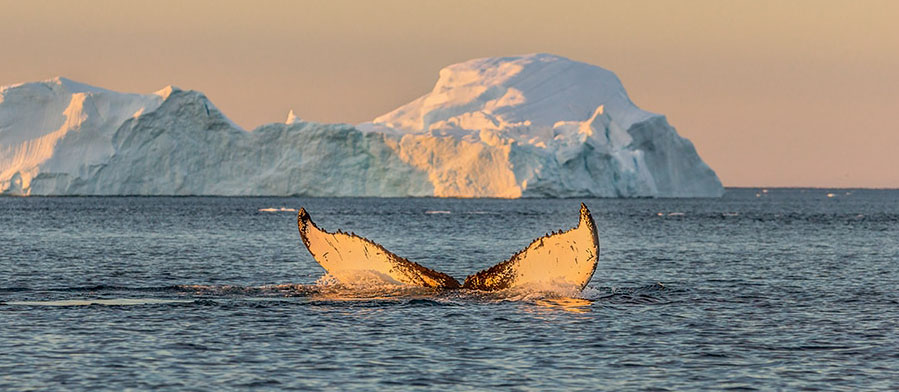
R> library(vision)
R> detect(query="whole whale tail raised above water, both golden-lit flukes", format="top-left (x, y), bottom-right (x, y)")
top-left (297, 203), bottom-right (600, 291)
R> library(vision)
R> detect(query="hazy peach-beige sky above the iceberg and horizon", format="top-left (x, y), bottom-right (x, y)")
top-left (0, 0), bottom-right (899, 188)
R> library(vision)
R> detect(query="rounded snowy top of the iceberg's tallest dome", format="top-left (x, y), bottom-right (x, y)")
top-left (372, 53), bottom-right (656, 140)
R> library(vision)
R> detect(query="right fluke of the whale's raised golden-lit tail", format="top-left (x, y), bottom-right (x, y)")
top-left (462, 203), bottom-right (599, 291)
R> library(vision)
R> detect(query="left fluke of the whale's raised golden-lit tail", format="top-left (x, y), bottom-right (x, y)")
top-left (297, 208), bottom-right (461, 289)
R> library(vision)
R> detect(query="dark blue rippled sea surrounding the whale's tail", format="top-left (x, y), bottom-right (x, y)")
top-left (0, 189), bottom-right (899, 390)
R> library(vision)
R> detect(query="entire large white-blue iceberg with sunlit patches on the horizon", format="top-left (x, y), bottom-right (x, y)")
top-left (0, 54), bottom-right (723, 198)
